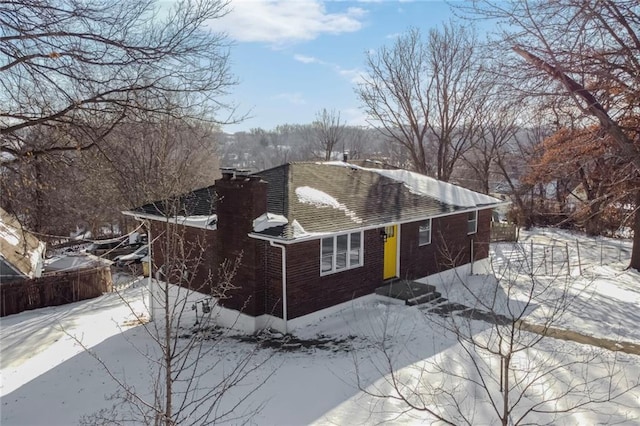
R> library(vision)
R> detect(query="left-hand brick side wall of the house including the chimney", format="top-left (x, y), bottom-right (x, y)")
top-left (152, 173), bottom-right (267, 316)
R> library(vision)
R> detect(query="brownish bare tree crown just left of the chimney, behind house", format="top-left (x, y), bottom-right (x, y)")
top-left (97, 113), bottom-right (219, 210)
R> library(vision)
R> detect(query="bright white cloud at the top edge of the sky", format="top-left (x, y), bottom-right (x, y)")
top-left (212, 0), bottom-right (366, 46)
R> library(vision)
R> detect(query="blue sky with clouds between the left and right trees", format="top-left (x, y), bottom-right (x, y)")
top-left (211, 0), bottom-right (460, 133)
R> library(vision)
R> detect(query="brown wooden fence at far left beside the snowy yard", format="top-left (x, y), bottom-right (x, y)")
top-left (0, 266), bottom-right (113, 316)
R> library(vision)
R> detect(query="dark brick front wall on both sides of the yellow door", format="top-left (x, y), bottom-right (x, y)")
top-left (276, 210), bottom-right (491, 319)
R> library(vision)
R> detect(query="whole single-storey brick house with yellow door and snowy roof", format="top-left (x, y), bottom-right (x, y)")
top-left (123, 162), bottom-right (504, 331)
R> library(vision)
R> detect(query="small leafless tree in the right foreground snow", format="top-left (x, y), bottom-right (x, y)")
top-left (354, 241), bottom-right (640, 425)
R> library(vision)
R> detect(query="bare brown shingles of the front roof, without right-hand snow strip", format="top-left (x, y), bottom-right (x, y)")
top-left (257, 163), bottom-right (459, 238)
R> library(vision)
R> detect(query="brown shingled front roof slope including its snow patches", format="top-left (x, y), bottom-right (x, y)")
top-left (252, 162), bottom-right (500, 239)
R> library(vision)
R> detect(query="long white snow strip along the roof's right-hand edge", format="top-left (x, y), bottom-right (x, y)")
top-left (320, 161), bottom-right (504, 207)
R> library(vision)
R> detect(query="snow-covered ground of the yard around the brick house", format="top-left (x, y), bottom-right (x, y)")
top-left (0, 230), bottom-right (640, 425)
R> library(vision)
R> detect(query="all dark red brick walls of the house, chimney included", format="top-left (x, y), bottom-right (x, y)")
top-left (154, 201), bottom-right (491, 319)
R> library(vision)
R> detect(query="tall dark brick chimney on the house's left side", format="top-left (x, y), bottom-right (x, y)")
top-left (215, 169), bottom-right (267, 316)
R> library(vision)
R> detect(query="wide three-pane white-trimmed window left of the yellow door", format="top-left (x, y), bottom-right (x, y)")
top-left (320, 231), bottom-right (364, 275)
